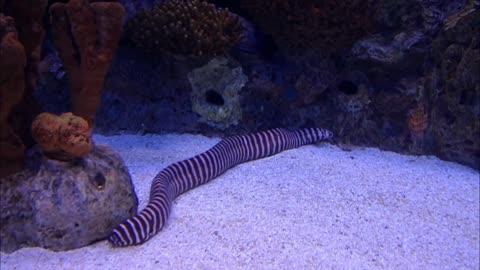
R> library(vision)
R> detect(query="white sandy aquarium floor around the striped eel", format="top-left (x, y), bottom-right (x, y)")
top-left (0, 135), bottom-right (480, 270)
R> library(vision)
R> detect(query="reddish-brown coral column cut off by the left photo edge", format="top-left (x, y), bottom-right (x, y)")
top-left (0, 13), bottom-right (26, 177)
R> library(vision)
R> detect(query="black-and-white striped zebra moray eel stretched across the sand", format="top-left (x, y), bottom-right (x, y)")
top-left (108, 128), bottom-right (333, 247)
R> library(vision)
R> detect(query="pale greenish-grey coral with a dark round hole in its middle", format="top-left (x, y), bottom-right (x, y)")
top-left (188, 57), bottom-right (247, 129)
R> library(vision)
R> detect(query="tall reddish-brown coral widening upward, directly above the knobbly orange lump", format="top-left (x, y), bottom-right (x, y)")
top-left (50, 0), bottom-right (125, 127)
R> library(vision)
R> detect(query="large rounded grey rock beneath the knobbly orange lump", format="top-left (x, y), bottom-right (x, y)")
top-left (0, 146), bottom-right (138, 252)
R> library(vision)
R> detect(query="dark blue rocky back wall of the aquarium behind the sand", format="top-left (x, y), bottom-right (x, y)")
top-left (15, 0), bottom-right (480, 169)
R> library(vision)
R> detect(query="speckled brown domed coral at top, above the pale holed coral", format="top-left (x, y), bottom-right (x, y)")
top-left (127, 0), bottom-right (243, 56)
